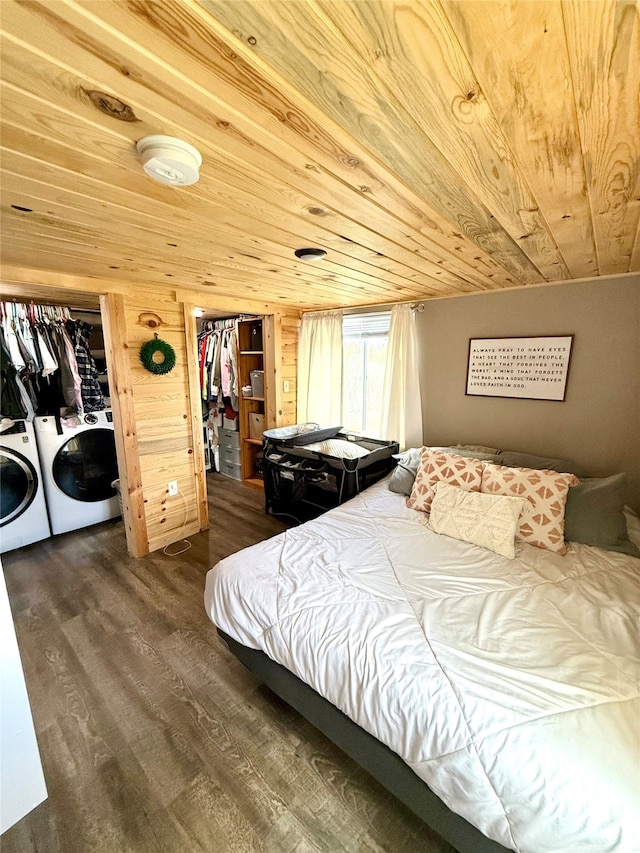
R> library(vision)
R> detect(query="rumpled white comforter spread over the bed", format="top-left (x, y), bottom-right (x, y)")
top-left (205, 480), bottom-right (640, 853)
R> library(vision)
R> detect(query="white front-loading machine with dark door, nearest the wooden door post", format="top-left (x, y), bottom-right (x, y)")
top-left (35, 409), bottom-right (120, 533)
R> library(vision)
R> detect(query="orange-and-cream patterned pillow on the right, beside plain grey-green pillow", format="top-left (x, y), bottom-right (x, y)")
top-left (482, 462), bottom-right (580, 554)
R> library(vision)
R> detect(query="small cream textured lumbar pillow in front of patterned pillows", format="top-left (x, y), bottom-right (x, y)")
top-left (427, 482), bottom-right (527, 559)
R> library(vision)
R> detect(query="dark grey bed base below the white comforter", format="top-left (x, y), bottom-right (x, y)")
top-left (217, 628), bottom-right (508, 853)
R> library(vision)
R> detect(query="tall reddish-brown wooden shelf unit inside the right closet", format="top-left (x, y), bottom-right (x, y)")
top-left (238, 317), bottom-right (274, 488)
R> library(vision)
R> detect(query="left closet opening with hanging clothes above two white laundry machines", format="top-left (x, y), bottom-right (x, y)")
top-left (0, 297), bottom-right (121, 553)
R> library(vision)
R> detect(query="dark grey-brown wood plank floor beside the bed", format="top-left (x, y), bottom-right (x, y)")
top-left (1, 474), bottom-right (452, 853)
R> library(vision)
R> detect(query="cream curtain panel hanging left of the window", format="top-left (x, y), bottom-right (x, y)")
top-left (298, 311), bottom-right (342, 426)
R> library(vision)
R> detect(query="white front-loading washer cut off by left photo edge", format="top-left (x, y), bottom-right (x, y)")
top-left (0, 420), bottom-right (51, 554)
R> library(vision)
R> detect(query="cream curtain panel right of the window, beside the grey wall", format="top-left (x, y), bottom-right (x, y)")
top-left (382, 304), bottom-right (423, 450)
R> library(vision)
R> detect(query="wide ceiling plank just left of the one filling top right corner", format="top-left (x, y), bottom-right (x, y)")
top-left (440, 0), bottom-right (597, 278)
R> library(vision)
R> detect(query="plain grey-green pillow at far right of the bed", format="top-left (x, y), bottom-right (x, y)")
top-left (564, 474), bottom-right (640, 557)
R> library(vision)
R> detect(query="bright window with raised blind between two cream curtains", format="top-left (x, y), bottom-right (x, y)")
top-left (342, 311), bottom-right (391, 438)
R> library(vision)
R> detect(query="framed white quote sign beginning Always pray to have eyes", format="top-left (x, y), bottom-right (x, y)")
top-left (466, 335), bottom-right (573, 401)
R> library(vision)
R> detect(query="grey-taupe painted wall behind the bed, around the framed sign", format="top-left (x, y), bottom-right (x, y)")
top-left (416, 275), bottom-right (640, 511)
